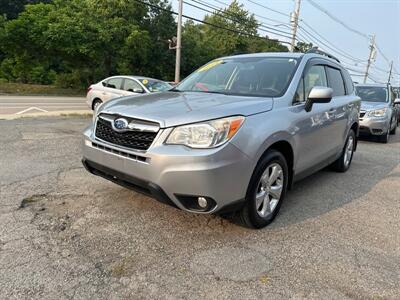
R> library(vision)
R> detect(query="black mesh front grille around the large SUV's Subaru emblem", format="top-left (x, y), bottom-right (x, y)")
top-left (96, 118), bottom-right (157, 150)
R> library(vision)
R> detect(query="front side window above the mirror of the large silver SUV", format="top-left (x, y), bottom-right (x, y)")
top-left (295, 65), bottom-right (328, 102)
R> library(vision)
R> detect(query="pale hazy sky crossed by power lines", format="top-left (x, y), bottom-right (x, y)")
top-left (171, 0), bottom-right (400, 85)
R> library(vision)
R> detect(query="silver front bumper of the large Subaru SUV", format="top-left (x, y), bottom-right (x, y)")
top-left (82, 128), bottom-right (253, 213)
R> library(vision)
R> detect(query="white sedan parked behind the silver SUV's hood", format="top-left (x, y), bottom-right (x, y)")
top-left (86, 76), bottom-right (172, 110)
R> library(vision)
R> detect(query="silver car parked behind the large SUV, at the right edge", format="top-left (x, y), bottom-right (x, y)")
top-left (356, 84), bottom-right (398, 143)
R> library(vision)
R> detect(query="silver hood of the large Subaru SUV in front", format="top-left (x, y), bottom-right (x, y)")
top-left (99, 92), bottom-right (273, 128)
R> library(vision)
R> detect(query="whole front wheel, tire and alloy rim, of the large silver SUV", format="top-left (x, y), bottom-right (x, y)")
top-left (239, 150), bottom-right (289, 228)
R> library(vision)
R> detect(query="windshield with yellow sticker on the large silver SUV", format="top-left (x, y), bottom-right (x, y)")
top-left (176, 57), bottom-right (298, 97)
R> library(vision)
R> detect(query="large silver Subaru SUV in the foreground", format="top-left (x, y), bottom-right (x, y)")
top-left (83, 53), bottom-right (360, 228)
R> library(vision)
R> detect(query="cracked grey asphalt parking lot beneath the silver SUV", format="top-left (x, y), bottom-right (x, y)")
top-left (0, 117), bottom-right (400, 299)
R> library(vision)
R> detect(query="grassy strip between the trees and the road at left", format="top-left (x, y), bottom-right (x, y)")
top-left (0, 81), bottom-right (86, 96)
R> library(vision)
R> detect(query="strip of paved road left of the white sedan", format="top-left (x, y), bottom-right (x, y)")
top-left (0, 95), bottom-right (89, 115)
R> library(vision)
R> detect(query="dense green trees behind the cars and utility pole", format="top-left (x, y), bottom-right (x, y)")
top-left (0, 0), bottom-right (287, 88)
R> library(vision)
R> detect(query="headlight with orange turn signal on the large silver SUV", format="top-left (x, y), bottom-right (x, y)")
top-left (165, 116), bottom-right (244, 148)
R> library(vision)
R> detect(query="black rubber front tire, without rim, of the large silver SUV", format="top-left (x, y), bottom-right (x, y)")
top-left (246, 150), bottom-right (289, 228)
